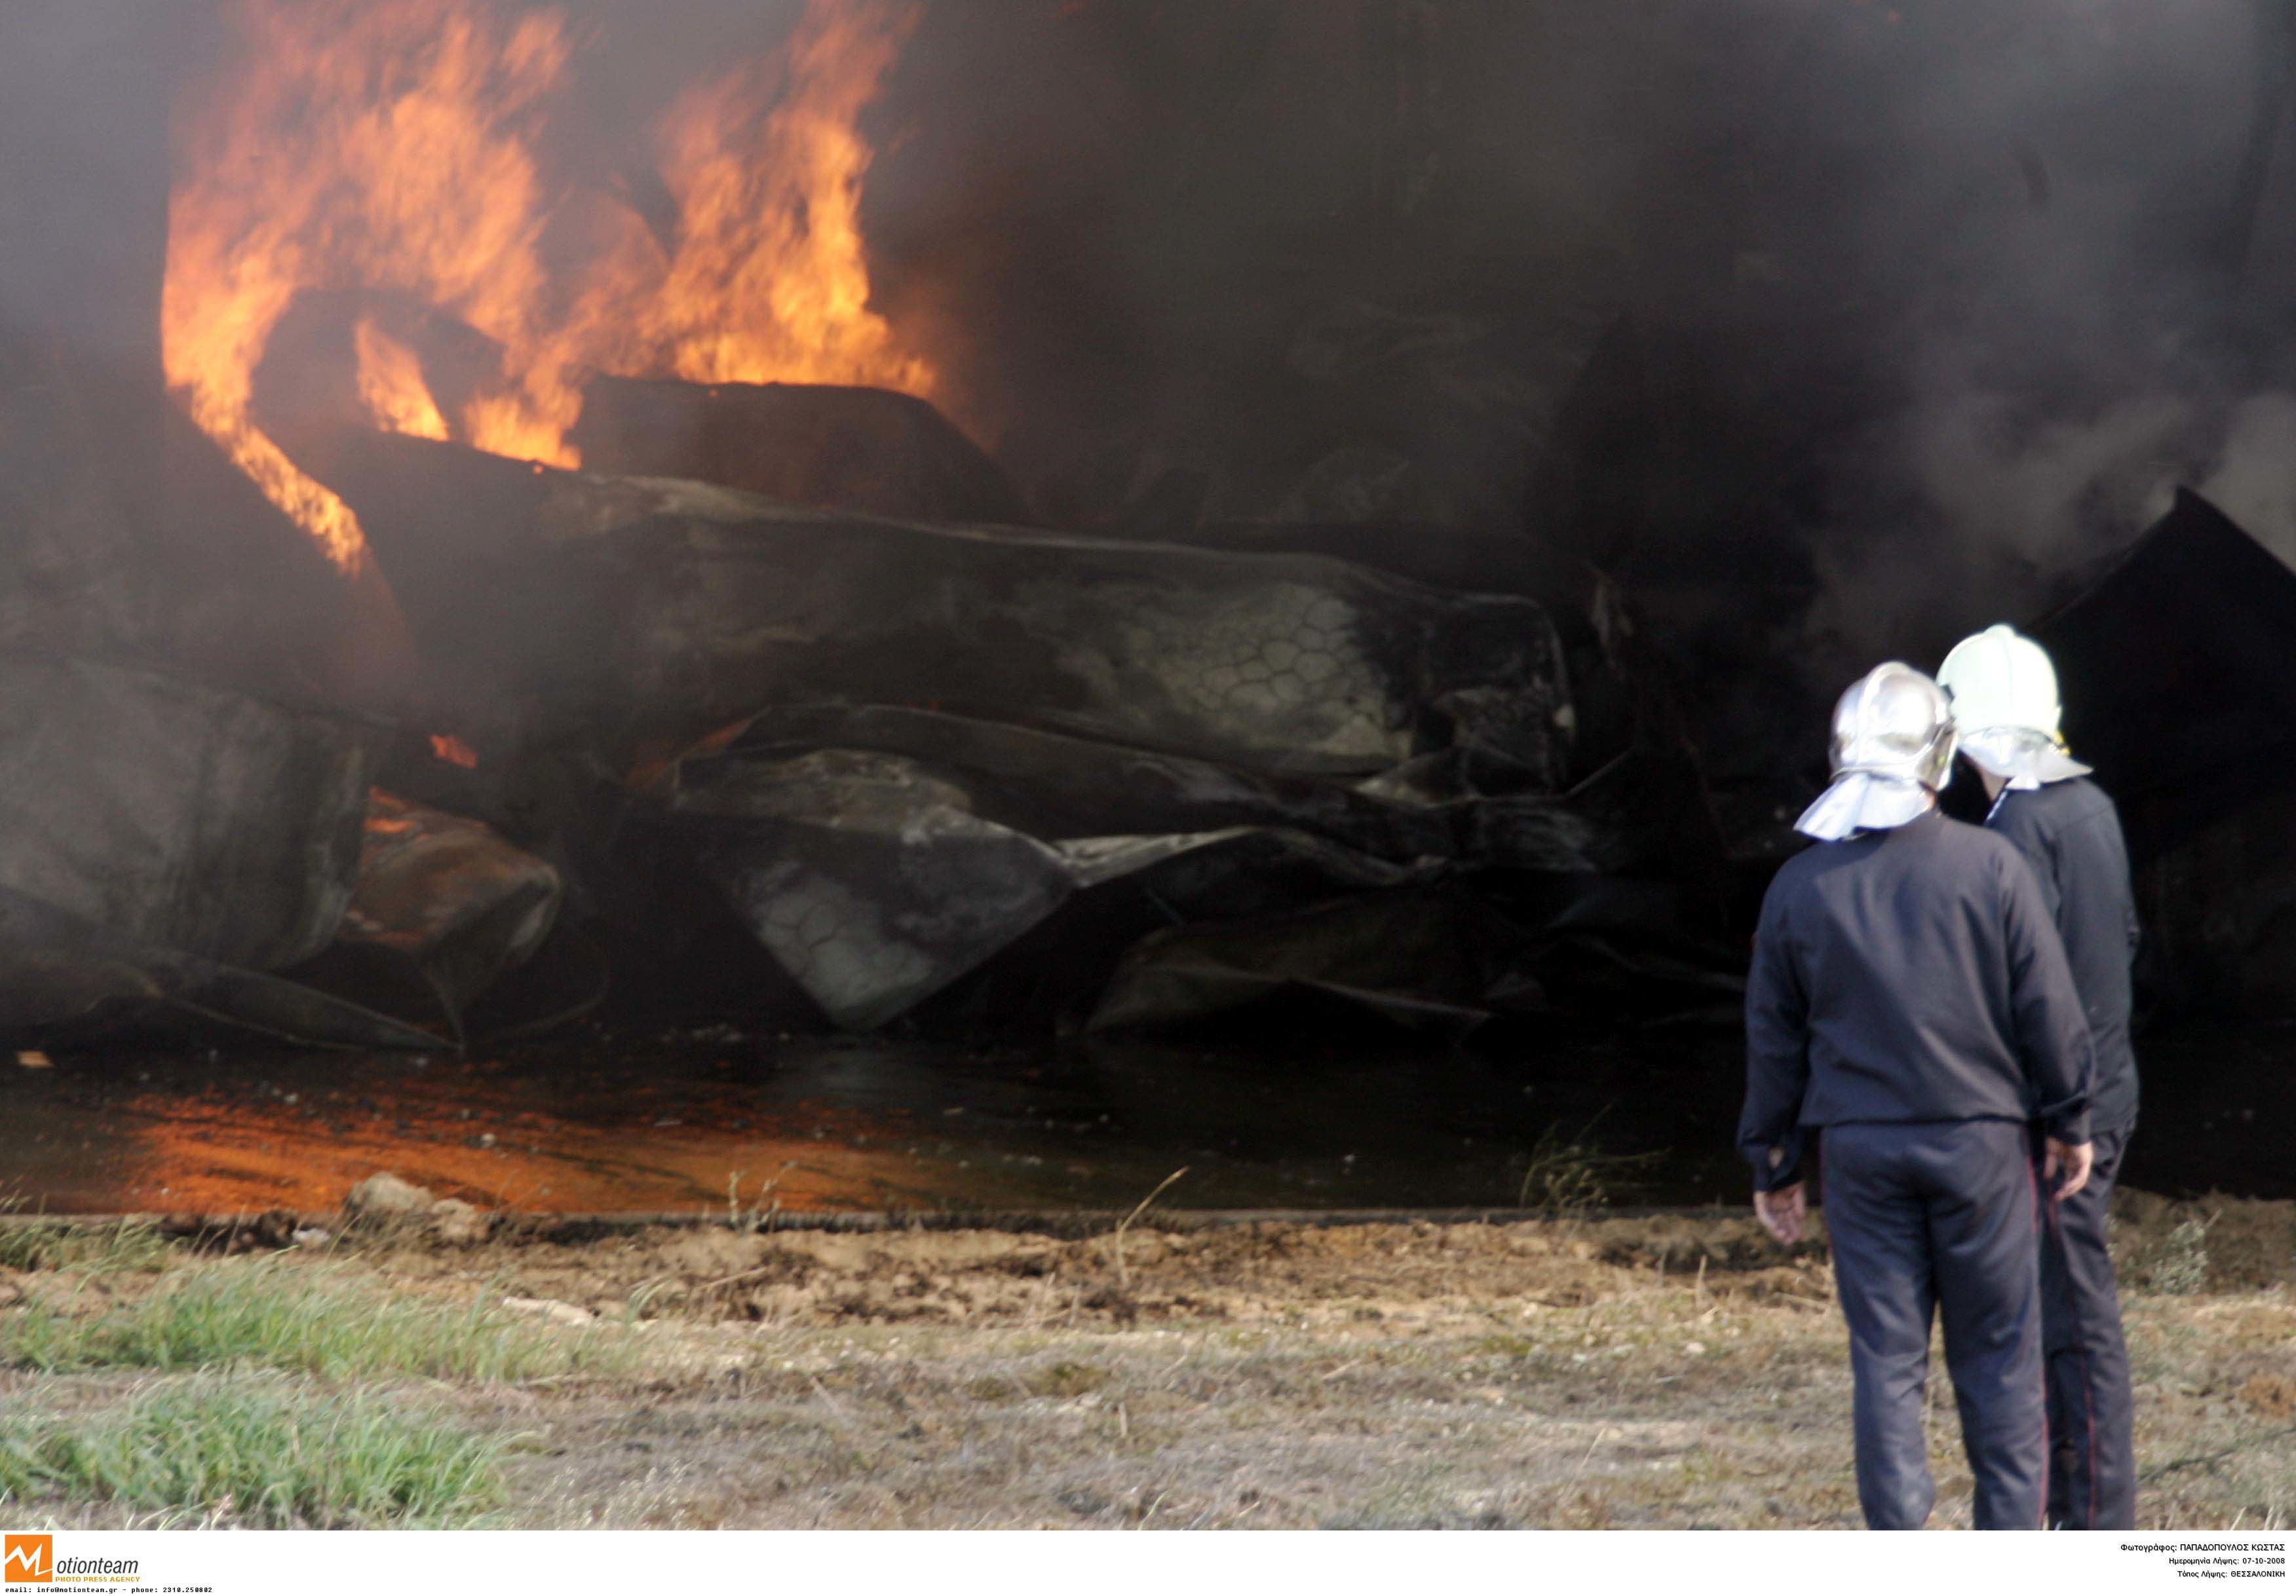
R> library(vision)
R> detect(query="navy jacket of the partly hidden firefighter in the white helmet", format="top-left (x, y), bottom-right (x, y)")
top-left (1986, 778), bottom-right (2137, 1132)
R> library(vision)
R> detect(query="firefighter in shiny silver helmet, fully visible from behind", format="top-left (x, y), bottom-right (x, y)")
top-left (1738, 664), bottom-right (2092, 1529)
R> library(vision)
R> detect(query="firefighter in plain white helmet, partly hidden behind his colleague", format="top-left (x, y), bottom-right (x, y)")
top-left (1938, 627), bottom-right (2137, 1529)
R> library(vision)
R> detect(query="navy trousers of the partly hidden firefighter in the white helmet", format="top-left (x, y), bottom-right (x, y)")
top-left (2041, 1130), bottom-right (2137, 1529)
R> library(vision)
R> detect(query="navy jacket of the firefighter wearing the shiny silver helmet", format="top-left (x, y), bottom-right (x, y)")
top-left (1738, 813), bottom-right (2094, 1190)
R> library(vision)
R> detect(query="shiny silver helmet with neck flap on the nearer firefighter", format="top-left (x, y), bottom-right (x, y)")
top-left (1793, 659), bottom-right (1954, 843)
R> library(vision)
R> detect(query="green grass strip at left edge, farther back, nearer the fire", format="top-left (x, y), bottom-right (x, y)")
top-left (0, 1261), bottom-right (634, 1382)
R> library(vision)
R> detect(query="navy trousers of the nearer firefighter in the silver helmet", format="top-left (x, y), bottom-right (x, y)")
top-left (1821, 1120), bottom-right (2048, 1529)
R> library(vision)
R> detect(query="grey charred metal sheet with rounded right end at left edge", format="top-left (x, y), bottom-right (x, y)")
top-left (0, 652), bottom-right (372, 969)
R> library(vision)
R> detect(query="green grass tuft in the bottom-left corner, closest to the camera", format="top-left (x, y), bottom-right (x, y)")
top-left (0, 1380), bottom-right (505, 1529)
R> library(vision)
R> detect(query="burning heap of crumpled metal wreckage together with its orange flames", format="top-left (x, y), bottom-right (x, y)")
top-left (0, 0), bottom-right (1754, 1047)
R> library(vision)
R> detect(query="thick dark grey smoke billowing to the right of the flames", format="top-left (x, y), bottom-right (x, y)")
top-left (849, 0), bottom-right (2296, 675)
